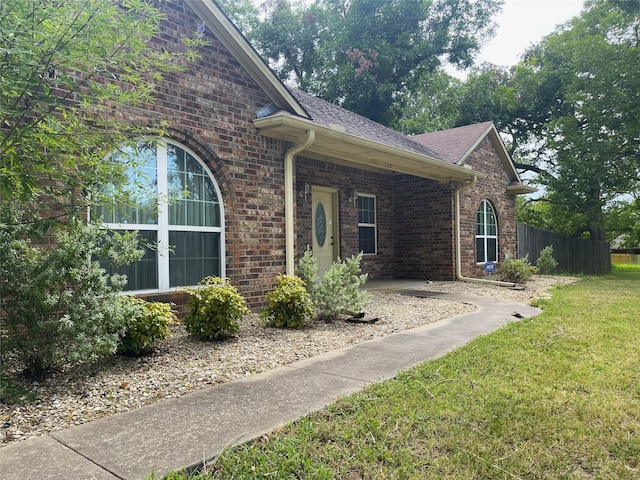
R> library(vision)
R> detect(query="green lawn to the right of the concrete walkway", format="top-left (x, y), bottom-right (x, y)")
top-left (167, 266), bottom-right (640, 480)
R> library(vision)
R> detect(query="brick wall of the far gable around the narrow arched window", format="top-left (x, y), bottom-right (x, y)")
top-left (460, 137), bottom-right (516, 277)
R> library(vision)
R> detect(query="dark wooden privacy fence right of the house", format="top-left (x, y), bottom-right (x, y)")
top-left (517, 223), bottom-right (611, 275)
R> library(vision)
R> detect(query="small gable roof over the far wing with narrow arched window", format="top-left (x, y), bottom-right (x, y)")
top-left (411, 122), bottom-right (536, 194)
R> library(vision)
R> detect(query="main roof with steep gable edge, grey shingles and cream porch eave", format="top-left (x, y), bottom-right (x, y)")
top-left (186, 0), bottom-right (486, 182)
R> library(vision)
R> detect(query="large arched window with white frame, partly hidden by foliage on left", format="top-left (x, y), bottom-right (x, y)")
top-left (91, 140), bottom-right (225, 292)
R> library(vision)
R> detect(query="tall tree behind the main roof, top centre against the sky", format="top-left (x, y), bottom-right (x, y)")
top-left (242, 0), bottom-right (502, 125)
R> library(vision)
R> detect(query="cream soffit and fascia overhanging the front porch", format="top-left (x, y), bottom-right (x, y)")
top-left (253, 113), bottom-right (487, 183)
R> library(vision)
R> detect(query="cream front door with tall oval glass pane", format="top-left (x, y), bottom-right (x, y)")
top-left (311, 187), bottom-right (338, 278)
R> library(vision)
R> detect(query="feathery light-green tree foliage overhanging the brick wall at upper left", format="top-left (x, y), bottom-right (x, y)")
top-left (0, 0), bottom-right (203, 214)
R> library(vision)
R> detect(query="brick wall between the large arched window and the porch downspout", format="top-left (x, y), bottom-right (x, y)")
top-left (100, 1), bottom-right (285, 306)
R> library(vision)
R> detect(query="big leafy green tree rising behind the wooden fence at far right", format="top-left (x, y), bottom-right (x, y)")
top-left (527, 0), bottom-right (640, 240)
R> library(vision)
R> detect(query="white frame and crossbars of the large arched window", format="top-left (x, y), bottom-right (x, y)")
top-left (92, 138), bottom-right (226, 294)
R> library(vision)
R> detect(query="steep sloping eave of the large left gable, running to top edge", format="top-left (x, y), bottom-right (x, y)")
top-left (187, 0), bottom-right (309, 118)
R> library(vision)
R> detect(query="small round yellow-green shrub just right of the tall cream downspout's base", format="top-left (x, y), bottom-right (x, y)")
top-left (261, 275), bottom-right (313, 329)
